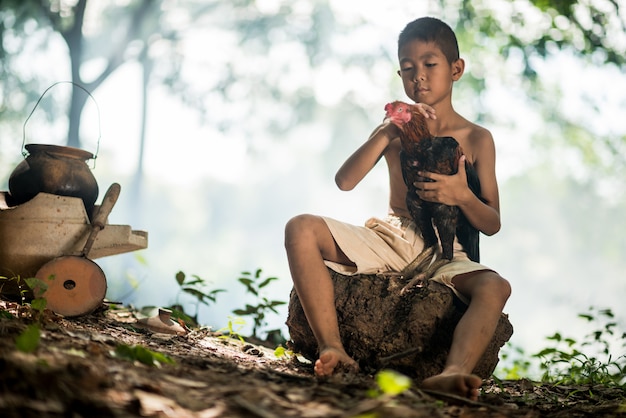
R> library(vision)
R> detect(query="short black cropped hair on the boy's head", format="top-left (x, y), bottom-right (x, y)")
top-left (398, 17), bottom-right (459, 64)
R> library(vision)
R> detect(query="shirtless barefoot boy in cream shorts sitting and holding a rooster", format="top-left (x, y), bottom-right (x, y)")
top-left (285, 18), bottom-right (511, 400)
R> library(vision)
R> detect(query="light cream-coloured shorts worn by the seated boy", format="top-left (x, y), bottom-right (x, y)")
top-left (322, 215), bottom-right (491, 303)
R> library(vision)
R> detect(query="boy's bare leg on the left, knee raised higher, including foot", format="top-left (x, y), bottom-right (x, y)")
top-left (285, 215), bottom-right (357, 376)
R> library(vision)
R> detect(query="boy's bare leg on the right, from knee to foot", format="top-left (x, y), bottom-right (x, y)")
top-left (422, 271), bottom-right (511, 400)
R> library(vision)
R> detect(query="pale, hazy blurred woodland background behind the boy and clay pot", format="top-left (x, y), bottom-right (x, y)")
top-left (0, 0), bottom-right (626, 372)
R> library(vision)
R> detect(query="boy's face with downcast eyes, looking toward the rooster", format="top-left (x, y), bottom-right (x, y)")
top-left (398, 40), bottom-right (465, 106)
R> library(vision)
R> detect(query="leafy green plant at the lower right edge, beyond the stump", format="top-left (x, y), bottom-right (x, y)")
top-left (534, 307), bottom-right (626, 386)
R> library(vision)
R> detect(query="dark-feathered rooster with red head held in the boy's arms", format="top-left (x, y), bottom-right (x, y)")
top-left (385, 101), bottom-right (480, 291)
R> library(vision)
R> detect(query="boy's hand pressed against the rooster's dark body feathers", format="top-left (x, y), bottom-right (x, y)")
top-left (413, 155), bottom-right (471, 206)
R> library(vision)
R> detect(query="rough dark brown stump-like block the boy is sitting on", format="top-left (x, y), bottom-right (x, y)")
top-left (287, 270), bottom-right (513, 381)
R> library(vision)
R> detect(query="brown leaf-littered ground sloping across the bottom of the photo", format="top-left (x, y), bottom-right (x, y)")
top-left (0, 301), bottom-right (626, 418)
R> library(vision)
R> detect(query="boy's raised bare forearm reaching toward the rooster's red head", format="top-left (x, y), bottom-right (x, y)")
top-left (335, 122), bottom-right (398, 190)
